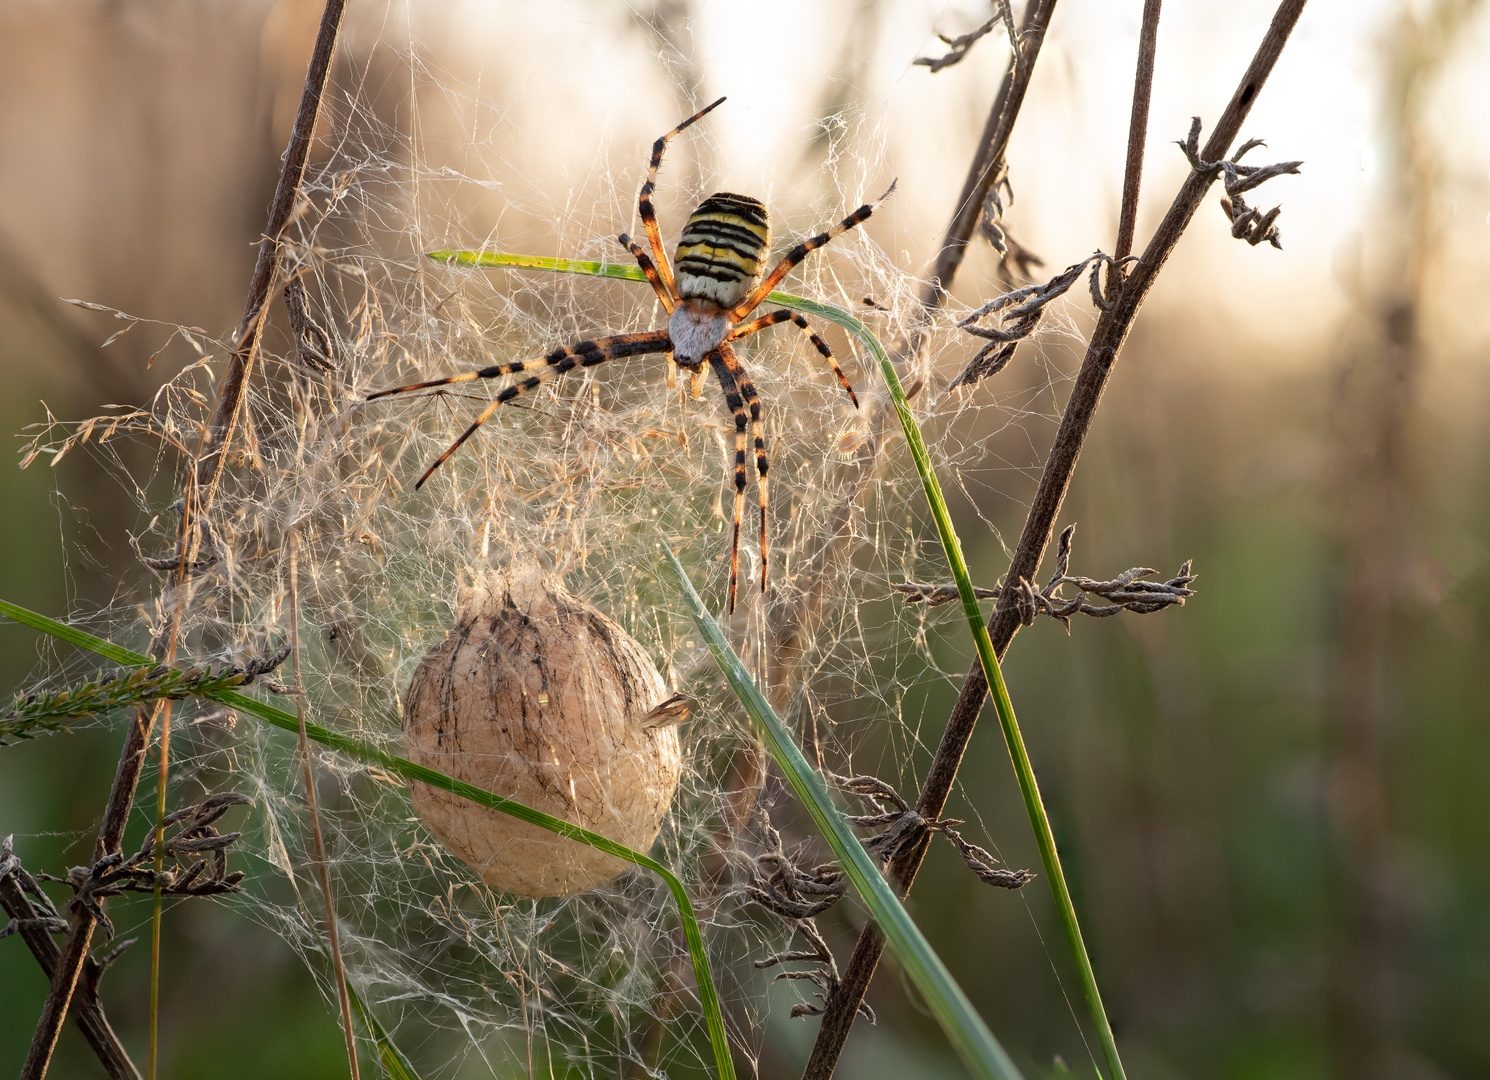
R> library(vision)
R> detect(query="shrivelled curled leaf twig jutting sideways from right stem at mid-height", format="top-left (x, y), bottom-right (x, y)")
top-left (894, 524), bottom-right (1198, 633)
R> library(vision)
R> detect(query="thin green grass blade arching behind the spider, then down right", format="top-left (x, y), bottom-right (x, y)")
top-left (441, 252), bottom-right (1126, 1080)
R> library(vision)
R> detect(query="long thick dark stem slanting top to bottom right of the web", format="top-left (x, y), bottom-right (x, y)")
top-left (803, 0), bottom-right (1305, 1080)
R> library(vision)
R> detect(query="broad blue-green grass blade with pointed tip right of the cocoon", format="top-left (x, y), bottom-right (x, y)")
top-left (662, 541), bottom-right (1019, 1080)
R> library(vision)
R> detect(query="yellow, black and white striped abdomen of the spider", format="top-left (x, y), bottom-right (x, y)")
top-left (673, 191), bottom-right (770, 308)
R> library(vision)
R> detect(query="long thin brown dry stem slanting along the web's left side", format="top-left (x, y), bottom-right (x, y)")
top-left (21, 0), bottom-right (346, 1080)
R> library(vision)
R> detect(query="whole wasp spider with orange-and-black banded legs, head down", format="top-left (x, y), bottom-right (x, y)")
top-left (368, 97), bottom-right (895, 612)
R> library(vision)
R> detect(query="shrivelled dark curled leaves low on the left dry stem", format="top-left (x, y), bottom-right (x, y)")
top-left (42, 791), bottom-right (253, 941)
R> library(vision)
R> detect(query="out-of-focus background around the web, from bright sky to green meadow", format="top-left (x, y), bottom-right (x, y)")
top-left (0, 0), bottom-right (1490, 1080)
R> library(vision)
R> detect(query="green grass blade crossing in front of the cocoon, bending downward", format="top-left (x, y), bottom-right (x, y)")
top-left (0, 600), bottom-right (735, 1080)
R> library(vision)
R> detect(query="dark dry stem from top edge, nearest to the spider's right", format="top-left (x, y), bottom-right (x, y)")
top-left (922, 0), bottom-right (1055, 296)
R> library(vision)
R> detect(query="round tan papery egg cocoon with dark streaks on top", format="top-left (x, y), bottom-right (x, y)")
top-left (404, 563), bottom-right (682, 897)
